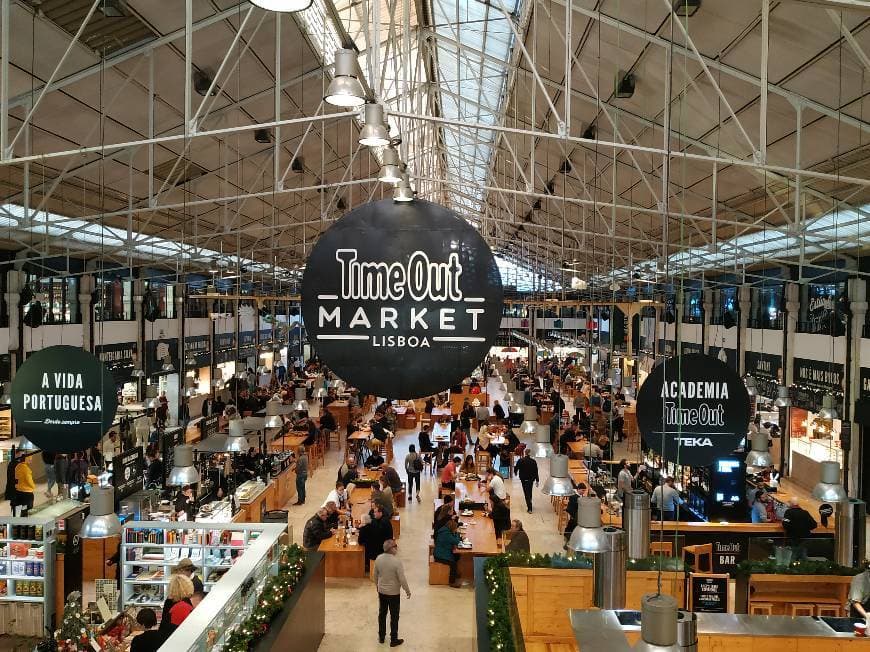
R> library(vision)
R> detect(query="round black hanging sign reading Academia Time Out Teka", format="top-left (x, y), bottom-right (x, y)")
top-left (637, 354), bottom-right (749, 466)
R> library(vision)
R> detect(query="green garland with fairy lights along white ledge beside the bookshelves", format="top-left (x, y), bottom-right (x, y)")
top-left (224, 544), bottom-right (305, 652)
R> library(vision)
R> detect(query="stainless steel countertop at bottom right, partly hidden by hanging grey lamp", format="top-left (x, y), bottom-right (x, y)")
top-left (570, 609), bottom-right (868, 652)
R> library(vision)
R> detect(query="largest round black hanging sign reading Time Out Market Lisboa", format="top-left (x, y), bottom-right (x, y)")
top-left (302, 200), bottom-right (502, 399)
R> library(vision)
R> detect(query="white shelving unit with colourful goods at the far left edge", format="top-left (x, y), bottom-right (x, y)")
top-left (0, 517), bottom-right (55, 636)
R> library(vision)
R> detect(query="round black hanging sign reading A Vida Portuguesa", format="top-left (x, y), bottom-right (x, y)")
top-left (12, 346), bottom-right (118, 453)
